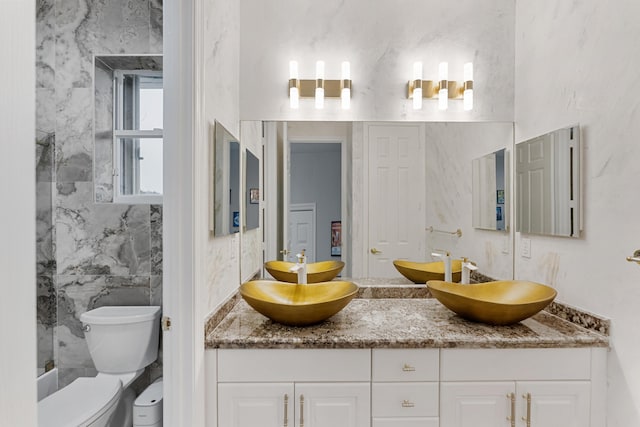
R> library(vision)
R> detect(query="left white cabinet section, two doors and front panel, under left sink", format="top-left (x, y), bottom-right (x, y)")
top-left (217, 350), bottom-right (371, 427)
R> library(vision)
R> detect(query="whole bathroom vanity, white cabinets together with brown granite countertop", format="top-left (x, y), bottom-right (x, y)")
top-left (206, 286), bottom-right (608, 427)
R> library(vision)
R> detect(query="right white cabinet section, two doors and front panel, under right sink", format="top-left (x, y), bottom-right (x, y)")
top-left (440, 348), bottom-right (605, 427)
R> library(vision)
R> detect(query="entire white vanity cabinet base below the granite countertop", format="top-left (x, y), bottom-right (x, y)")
top-left (207, 347), bottom-right (607, 427)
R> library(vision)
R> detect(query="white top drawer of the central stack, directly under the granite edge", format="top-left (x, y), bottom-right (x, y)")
top-left (371, 349), bottom-right (440, 381)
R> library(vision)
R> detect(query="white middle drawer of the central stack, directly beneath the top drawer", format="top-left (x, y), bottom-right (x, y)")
top-left (371, 382), bottom-right (439, 417)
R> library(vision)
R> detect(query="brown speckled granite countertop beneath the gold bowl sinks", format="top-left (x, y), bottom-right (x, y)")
top-left (205, 296), bottom-right (609, 349)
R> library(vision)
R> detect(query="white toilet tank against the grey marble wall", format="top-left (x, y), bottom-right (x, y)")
top-left (80, 306), bottom-right (160, 374)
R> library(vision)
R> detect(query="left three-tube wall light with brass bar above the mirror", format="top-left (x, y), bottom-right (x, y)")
top-left (289, 61), bottom-right (351, 110)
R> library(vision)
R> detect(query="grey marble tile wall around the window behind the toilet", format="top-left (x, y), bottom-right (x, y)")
top-left (36, 0), bottom-right (162, 386)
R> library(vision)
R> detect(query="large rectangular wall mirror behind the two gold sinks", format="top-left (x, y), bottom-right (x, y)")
top-left (263, 122), bottom-right (513, 283)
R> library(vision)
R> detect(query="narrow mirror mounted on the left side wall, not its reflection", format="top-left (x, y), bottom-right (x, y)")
top-left (210, 121), bottom-right (240, 236)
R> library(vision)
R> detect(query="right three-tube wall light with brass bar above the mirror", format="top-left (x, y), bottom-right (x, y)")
top-left (407, 62), bottom-right (473, 111)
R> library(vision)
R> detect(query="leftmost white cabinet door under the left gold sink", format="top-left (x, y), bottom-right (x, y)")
top-left (218, 383), bottom-right (294, 427)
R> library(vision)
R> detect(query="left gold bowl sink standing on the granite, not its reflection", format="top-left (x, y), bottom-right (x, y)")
top-left (240, 280), bottom-right (358, 326)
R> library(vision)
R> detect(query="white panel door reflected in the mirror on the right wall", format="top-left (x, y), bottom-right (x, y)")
top-left (516, 136), bottom-right (554, 234)
